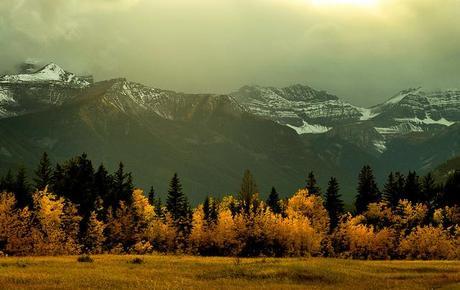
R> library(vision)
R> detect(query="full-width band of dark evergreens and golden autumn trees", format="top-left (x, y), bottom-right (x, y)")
top-left (0, 153), bottom-right (460, 259)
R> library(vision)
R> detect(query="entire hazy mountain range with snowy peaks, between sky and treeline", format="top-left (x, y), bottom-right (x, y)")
top-left (0, 64), bottom-right (460, 201)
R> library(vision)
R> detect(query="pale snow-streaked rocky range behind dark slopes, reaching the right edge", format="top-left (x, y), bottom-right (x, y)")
top-left (232, 85), bottom-right (460, 155)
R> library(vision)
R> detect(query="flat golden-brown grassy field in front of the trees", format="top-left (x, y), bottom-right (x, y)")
top-left (0, 255), bottom-right (460, 290)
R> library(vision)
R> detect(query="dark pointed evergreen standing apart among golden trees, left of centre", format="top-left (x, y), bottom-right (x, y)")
top-left (166, 173), bottom-right (190, 225)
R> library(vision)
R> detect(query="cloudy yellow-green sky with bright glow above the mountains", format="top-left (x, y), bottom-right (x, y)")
top-left (0, 0), bottom-right (460, 106)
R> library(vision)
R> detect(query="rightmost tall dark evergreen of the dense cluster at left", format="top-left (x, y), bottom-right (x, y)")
top-left (111, 162), bottom-right (134, 209)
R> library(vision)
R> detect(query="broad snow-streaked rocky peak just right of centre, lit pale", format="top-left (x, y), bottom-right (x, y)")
top-left (232, 85), bottom-right (380, 134)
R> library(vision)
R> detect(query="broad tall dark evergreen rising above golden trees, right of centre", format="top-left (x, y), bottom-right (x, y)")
top-left (355, 165), bottom-right (380, 214)
